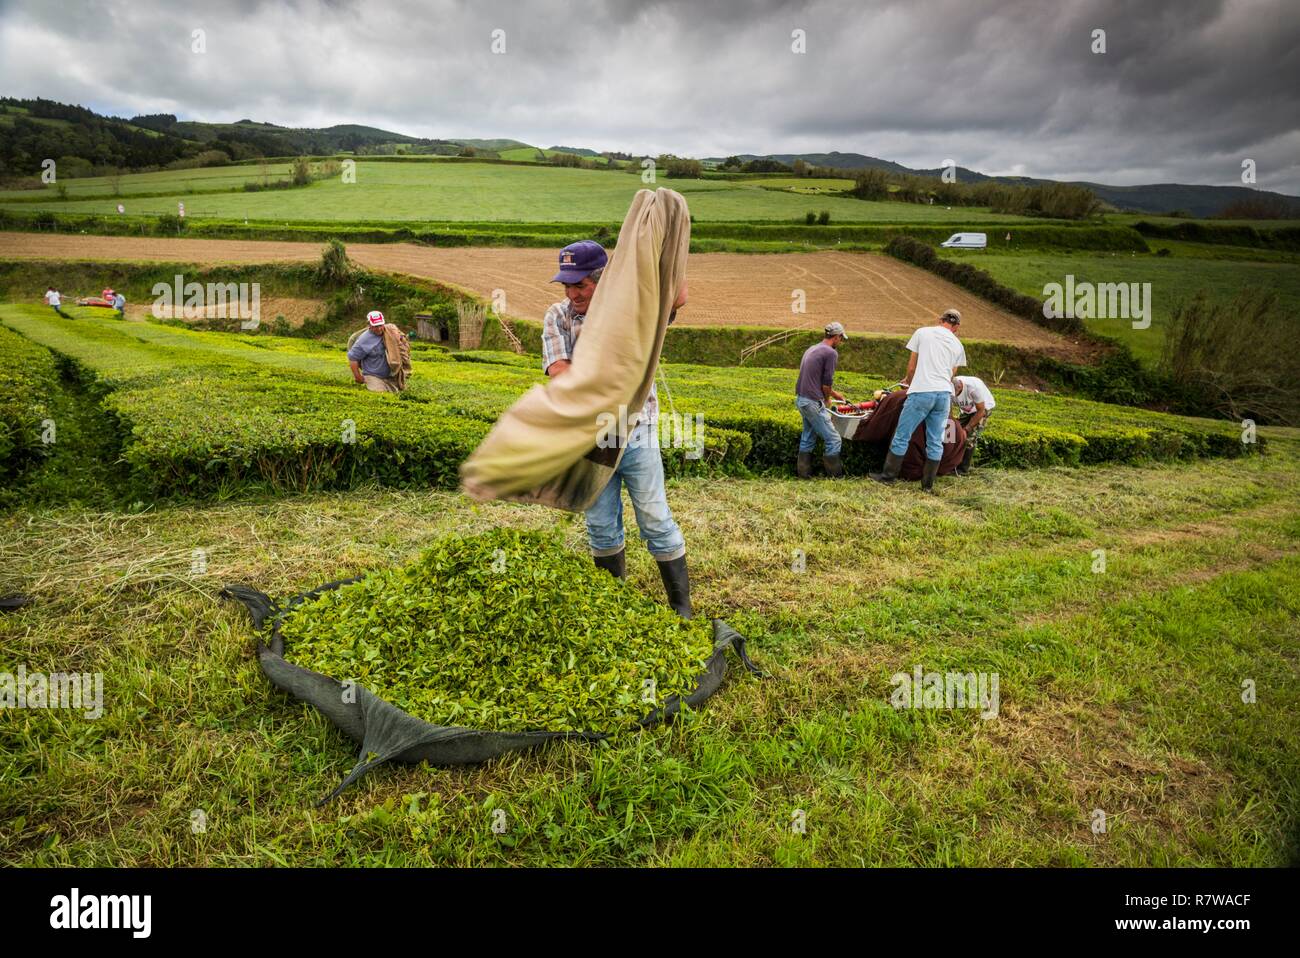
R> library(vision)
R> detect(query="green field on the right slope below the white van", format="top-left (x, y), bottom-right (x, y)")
top-left (941, 240), bottom-right (1300, 363)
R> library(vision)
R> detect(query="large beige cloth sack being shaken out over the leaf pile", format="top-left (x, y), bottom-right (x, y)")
top-left (460, 190), bottom-right (690, 512)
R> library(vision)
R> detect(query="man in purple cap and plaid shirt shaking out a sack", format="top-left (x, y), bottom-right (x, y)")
top-left (542, 239), bottom-right (692, 619)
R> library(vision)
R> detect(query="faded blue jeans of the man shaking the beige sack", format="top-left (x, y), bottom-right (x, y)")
top-left (585, 424), bottom-right (686, 562)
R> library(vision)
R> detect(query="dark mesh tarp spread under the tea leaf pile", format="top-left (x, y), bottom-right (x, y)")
top-left (222, 578), bottom-right (763, 805)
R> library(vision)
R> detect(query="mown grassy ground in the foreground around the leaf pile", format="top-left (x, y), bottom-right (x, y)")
top-left (0, 442), bottom-right (1300, 867)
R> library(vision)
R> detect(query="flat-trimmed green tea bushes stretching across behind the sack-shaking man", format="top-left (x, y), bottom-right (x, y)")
top-left (0, 307), bottom-right (1258, 497)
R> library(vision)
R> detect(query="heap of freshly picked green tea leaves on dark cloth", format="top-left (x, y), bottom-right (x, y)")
top-left (281, 529), bottom-right (712, 732)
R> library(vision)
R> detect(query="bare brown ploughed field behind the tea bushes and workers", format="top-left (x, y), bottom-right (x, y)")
top-left (0, 233), bottom-right (1091, 359)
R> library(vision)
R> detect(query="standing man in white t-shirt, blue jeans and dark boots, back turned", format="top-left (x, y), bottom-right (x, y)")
top-left (871, 309), bottom-right (966, 493)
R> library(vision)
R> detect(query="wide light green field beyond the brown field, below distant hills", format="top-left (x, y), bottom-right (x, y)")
top-left (0, 160), bottom-right (1026, 225)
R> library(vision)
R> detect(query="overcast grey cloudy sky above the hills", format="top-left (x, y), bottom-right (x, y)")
top-left (0, 0), bottom-right (1300, 194)
